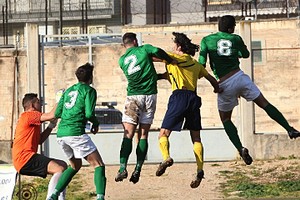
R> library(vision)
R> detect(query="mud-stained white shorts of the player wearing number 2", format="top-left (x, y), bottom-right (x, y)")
top-left (122, 94), bottom-right (157, 125)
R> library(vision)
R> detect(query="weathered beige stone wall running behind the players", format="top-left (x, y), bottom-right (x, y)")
top-left (0, 19), bottom-right (300, 162)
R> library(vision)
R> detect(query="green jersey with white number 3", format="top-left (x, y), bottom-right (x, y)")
top-left (55, 82), bottom-right (99, 137)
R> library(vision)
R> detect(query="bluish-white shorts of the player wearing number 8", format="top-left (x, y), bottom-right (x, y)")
top-left (218, 70), bottom-right (260, 112)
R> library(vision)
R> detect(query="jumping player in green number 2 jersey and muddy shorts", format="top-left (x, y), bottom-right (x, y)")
top-left (115, 33), bottom-right (173, 184)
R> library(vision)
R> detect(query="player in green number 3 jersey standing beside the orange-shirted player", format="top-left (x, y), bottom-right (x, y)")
top-left (50, 63), bottom-right (106, 200)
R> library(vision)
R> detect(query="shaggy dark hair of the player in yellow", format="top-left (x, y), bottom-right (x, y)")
top-left (172, 32), bottom-right (199, 56)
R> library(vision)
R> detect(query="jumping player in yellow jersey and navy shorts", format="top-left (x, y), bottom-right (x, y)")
top-left (156, 32), bottom-right (221, 188)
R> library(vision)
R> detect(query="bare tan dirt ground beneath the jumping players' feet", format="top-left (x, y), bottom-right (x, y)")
top-left (79, 162), bottom-right (235, 200)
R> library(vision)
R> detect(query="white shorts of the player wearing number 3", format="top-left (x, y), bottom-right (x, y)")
top-left (57, 134), bottom-right (97, 159)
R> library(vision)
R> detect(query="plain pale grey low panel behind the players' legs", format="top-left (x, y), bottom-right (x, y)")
top-left (47, 129), bottom-right (238, 164)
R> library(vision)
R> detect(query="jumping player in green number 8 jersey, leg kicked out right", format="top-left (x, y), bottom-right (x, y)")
top-left (198, 15), bottom-right (300, 165)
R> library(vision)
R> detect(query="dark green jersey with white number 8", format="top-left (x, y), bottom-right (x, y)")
top-left (198, 32), bottom-right (250, 78)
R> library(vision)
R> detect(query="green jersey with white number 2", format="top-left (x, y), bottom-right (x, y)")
top-left (119, 44), bottom-right (172, 96)
